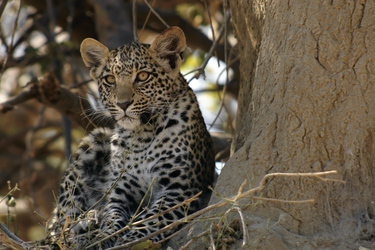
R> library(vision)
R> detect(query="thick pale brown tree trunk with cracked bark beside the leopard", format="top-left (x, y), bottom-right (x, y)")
top-left (170, 0), bottom-right (375, 249)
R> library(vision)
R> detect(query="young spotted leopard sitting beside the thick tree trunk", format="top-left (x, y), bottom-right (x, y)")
top-left (48, 27), bottom-right (215, 249)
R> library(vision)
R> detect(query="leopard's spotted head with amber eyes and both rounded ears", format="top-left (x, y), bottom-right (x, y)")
top-left (81, 27), bottom-right (186, 127)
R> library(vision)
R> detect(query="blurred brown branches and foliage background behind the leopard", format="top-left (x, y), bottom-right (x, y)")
top-left (0, 0), bottom-right (240, 240)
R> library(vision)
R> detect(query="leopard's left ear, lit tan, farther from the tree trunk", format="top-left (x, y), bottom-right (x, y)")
top-left (81, 38), bottom-right (109, 78)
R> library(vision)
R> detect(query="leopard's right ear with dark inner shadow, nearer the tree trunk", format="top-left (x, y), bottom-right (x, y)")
top-left (150, 27), bottom-right (186, 76)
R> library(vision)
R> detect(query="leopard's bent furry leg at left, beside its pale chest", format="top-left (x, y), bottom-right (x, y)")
top-left (47, 129), bottom-right (112, 246)
